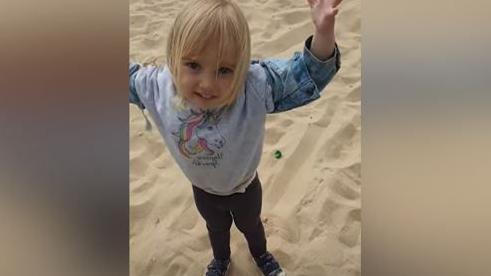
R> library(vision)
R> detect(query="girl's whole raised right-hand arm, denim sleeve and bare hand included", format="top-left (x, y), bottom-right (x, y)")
top-left (253, 0), bottom-right (341, 113)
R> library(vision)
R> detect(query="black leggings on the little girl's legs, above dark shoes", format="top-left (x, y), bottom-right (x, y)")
top-left (193, 175), bottom-right (266, 259)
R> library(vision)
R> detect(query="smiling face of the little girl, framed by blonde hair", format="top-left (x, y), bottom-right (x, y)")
top-left (179, 42), bottom-right (236, 109)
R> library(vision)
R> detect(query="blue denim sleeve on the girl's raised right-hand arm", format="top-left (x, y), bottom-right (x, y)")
top-left (253, 36), bottom-right (340, 113)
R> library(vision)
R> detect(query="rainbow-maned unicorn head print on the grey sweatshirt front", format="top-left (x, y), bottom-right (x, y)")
top-left (174, 110), bottom-right (225, 159)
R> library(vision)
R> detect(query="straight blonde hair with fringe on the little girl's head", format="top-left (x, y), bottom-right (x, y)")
top-left (167, 0), bottom-right (251, 105)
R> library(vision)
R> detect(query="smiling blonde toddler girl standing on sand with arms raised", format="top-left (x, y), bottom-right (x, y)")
top-left (129, 0), bottom-right (341, 276)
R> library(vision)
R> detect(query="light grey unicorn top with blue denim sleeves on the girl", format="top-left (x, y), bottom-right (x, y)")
top-left (129, 36), bottom-right (340, 195)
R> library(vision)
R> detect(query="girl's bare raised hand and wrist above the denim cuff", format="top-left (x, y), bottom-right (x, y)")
top-left (307, 0), bottom-right (342, 60)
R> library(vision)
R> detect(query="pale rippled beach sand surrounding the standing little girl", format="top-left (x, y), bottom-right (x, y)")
top-left (129, 0), bottom-right (361, 276)
